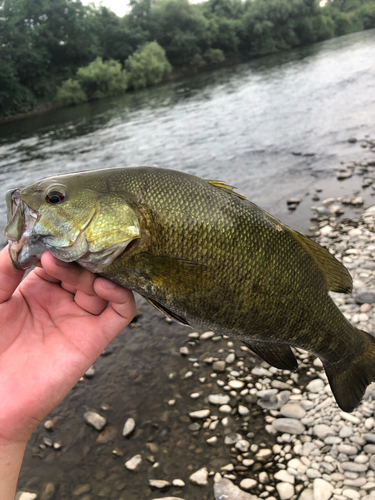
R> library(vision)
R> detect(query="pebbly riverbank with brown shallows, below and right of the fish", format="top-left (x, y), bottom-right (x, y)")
top-left (18, 138), bottom-right (375, 500)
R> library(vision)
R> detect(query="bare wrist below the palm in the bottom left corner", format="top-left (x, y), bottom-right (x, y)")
top-left (0, 443), bottom-right (26, 500)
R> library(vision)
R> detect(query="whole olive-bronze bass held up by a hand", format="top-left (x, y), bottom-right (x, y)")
top-left (5, 166), bottom-right (375, 412)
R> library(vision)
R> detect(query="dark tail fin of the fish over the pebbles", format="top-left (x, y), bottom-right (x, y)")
top-left (323, 329), bottom-right (375, 412)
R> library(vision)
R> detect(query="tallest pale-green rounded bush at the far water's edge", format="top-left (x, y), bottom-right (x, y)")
top-left (125, 42), bottom-right (172, 90)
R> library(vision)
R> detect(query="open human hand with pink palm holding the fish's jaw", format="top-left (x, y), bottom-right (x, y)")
top-left (0, 248), bottom-right (136, 446)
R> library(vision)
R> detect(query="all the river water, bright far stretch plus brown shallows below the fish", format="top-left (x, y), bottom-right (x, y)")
top-left (4, 30), bottom-right (375, 500)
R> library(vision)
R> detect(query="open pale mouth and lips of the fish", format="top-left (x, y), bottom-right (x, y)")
top-left (5, 189), bottom-right (47, 269)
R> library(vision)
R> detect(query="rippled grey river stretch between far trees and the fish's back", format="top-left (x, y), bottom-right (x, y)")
top-left (0, 30), bottom-right (375, 240)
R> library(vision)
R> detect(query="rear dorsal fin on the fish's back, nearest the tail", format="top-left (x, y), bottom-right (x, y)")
top-left (292, 231), bottom-right (353, 293)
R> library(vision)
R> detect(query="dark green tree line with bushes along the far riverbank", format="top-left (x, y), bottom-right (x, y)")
top-left (0, 0), bottom-right (375, 116)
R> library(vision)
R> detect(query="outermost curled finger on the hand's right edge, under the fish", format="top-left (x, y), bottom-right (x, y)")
top-left (94, 278), bottom-right (137, 342)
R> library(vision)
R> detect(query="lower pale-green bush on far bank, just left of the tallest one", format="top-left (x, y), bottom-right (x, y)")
top-left (77, 57), bottom-right (127, 101)
